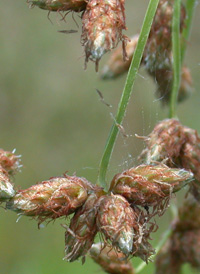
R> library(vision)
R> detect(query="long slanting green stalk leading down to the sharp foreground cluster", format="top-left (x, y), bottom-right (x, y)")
top-left (98, 0), bottom-right (159, 188)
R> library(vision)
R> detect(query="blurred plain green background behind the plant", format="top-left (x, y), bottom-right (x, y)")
top-left (0, 0), bottom-right (200, 274)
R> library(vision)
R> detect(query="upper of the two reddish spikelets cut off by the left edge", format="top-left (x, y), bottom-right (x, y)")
top-left (0, 149), bottom-right (21, 175)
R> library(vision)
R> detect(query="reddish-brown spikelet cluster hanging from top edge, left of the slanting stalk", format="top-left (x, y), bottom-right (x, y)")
top-left (28, 0), bottom-right (127, 71)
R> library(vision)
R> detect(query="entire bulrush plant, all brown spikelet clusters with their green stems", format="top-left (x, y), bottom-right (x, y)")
top-left (0, 0), bottom-right (200, 274)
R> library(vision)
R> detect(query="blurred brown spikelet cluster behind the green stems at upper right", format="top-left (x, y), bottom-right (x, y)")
top-left (101, 0), bottom-right (192, 103)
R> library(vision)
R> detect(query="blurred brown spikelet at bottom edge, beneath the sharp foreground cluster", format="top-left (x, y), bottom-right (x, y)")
top-left (90, 243), bottom-right (135, 274)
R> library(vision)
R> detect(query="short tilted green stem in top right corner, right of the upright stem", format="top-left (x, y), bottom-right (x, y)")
top-left (181, 0), bottom-right (196, 63)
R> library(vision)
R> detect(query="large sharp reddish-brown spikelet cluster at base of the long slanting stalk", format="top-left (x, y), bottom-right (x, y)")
top-left (0, 143), bottom-right (193, 262)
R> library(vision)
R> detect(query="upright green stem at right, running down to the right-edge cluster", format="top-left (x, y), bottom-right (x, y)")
top-left (169, 0), bottom-right (181, 118)
